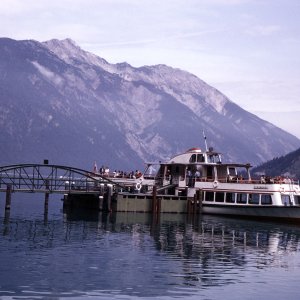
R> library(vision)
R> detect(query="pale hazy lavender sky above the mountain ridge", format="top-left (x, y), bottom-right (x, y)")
top-left (0, 0), bottom-right (300, 138)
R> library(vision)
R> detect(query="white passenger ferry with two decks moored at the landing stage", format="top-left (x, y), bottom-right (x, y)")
top-left (137, 147), bottom-right (300, 220)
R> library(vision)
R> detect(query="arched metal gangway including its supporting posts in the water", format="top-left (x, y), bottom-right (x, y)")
top-left (0, 164), bottom-right (131, 212)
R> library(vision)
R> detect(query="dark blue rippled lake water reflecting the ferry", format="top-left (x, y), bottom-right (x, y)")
top-left (0, 193), bottom-right (300, 300)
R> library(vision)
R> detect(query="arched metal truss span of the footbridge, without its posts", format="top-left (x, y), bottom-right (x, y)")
top-left (0, 164), bottom-right (122, 193)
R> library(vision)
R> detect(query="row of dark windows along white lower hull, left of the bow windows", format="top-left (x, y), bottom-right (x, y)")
top-left (203, 191), bottom-right (272, 205)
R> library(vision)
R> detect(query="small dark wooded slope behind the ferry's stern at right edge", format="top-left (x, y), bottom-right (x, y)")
top-left (252, 148), bottom-right (300, 180)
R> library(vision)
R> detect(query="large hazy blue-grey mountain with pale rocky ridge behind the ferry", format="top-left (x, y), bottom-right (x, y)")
top-left (0, 38), bottom-right (300, 170)
